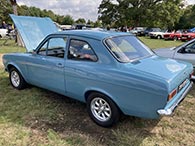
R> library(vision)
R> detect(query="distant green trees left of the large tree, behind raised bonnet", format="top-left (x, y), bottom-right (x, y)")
top-left (0, 0), bottom-right (101, 27)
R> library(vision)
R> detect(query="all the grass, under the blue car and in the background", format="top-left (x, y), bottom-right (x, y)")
top-left (0, 38), bottom-right (195, 146)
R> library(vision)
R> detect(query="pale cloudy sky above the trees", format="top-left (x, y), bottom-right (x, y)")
top-left (17, 0), bottom-right (195, 21)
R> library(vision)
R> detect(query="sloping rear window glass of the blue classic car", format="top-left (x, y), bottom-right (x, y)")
top-left (105, 35), bottom-right (153, 62)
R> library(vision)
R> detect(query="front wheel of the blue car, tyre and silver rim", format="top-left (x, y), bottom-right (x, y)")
top-left (9, 67), bottom-right (27, 90)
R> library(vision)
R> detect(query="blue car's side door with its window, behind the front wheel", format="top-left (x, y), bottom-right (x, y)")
top-left (27, 37), bottom-right (67, 94)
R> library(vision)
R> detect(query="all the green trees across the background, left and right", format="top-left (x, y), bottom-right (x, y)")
top-left (0, 0), bottom-right (195, 29)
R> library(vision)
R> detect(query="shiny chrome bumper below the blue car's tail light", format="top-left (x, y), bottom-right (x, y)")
top-left (157, 81), bottom-right (195, 116)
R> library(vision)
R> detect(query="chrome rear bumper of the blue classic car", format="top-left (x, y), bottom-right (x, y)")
top-left (157, 82), bottom-right (193, 116)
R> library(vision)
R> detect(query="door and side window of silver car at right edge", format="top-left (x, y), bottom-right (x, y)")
top-left (174, 41), bottom-right (195, 66)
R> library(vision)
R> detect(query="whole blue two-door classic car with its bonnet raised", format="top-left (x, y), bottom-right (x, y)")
top-left (3, 15), bottom-right (193, 127)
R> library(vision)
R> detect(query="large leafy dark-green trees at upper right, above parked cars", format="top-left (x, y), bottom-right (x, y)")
top-left (98, 0), bottom-right (195, 29)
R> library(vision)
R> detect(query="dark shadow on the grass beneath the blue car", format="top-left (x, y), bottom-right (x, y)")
top-left (21, 87), bottom-right (159, 146)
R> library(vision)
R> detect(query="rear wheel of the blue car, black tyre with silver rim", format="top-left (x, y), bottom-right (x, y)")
top-left (87, 93), bottom-right (120, 127)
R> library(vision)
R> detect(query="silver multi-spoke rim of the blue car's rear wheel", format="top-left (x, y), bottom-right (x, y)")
top-left (90, 97), bottom-right (112, 122)
